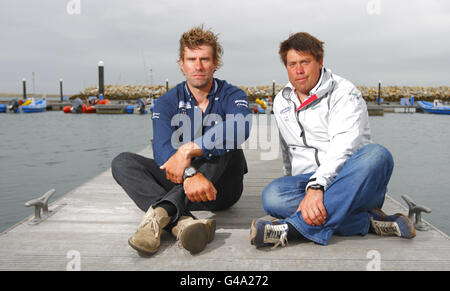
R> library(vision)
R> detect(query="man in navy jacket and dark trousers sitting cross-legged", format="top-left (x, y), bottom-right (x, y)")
top-left (112, 27), bottom-right (251, 255)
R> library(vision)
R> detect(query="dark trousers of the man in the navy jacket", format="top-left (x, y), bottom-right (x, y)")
top-left (111, 150), bottom-right (246, 227)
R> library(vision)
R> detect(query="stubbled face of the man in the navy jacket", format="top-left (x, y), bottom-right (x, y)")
top-left (180, 45), bottom-right (217, 89)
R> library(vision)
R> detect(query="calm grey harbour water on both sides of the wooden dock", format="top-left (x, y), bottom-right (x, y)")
top-left (0, 112), bottom-right (450, 234)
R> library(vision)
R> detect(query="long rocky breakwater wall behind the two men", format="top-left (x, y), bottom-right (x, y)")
top-left (70, 85), bottom-right (450, 102)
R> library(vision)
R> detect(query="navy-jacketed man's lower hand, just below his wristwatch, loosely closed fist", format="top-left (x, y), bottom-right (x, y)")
top-left (183, 172), bottom-right (217, 202)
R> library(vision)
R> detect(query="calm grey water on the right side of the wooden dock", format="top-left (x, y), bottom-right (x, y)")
top-left (370, 113), bottom-right (450, 234)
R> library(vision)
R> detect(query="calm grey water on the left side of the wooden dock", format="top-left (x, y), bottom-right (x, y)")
top-left (0, 111), bottom-right (152, 231)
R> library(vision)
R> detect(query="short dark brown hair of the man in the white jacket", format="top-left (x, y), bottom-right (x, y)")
top-left (278, 32), bottom-right (324, 66)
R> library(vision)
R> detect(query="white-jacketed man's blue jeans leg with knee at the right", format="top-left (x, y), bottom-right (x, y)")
top-left (286, 144), bottom-right (393, 245)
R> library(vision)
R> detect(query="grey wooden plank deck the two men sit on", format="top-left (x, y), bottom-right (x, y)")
top-left (0, 149), bottom-right (450, 270)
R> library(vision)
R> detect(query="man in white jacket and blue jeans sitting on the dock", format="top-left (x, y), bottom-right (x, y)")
top-left (250, 33), bottom-right (415, 247)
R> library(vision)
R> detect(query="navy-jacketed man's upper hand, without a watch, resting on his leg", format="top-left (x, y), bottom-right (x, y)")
top-left (160, 142), bottom-right (203, 184)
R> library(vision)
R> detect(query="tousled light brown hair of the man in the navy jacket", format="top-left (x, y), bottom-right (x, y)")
top-left (178, 25), bottom-right (223, 68)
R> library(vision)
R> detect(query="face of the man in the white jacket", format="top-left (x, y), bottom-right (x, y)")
top-left (286, 49), bottom-right (323, 95)
